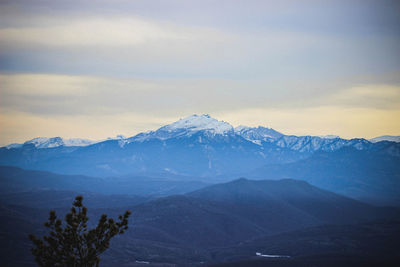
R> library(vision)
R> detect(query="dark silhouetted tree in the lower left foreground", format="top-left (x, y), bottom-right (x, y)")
top-left (29, 196), bottom-right (131, 267)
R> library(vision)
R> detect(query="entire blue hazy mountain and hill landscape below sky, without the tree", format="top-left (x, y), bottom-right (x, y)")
top-left (0, 115), bottom-right (400, 266)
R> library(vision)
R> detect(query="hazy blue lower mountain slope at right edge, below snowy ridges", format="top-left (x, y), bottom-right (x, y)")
top-left (244, 147), bottom-right (400, 206)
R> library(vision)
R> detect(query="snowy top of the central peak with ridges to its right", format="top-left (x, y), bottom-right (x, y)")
top-left (127, 115), bottom-right (369, 152)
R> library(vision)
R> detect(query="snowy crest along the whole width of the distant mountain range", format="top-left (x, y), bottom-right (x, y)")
top-left (6, 114), bottom-right (400, 156)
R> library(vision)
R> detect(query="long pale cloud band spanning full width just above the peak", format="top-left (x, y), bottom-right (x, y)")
top-left (0, 74), bottom-right (400, 116)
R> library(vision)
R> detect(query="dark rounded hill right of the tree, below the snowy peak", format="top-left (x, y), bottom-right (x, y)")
top-left (124, 178), bottom-right (390, 247)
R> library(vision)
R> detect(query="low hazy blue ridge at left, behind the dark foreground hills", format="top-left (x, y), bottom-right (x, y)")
top-left (0, 166), bottom-right (209, 198)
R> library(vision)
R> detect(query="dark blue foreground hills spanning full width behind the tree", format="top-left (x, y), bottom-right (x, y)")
top-left (0, 179), bottom-right (400, 266)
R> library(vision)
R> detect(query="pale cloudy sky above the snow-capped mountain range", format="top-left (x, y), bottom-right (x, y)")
top-left (0, 0), bottom-right (400, 145)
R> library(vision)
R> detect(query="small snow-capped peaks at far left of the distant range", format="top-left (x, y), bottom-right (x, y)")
top-left (6, 137), bottom-right (96, 149)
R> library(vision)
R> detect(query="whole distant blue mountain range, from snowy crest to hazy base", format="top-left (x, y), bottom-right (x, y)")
top-left (0, 115), bottom-right (400, 205)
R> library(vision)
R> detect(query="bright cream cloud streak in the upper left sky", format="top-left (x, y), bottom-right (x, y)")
top-left (0, 17), bottom-right (210, 47)
